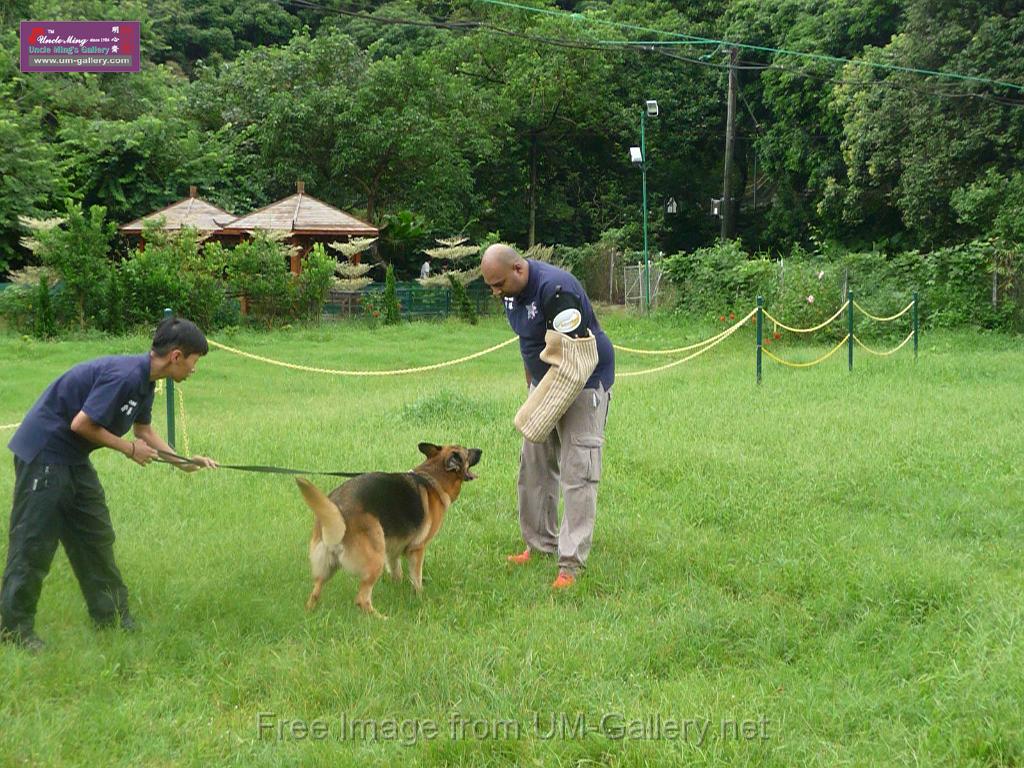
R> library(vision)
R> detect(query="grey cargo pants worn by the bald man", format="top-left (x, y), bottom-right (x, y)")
top-left (519, 385), bottom-right (611, 573)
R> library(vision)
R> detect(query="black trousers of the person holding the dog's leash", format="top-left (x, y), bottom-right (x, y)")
top-left (0, 457), bottom-right (128, 631)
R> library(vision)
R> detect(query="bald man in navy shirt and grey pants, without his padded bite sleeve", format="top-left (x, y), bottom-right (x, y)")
top-left (480, 244), bottom-right (615, 589)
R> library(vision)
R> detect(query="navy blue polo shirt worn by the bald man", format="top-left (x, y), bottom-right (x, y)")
top-left (505, 259), bottom-right (615, 390)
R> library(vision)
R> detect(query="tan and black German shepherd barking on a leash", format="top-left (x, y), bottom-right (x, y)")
top-left (296, 442), bottom-right (482, 617)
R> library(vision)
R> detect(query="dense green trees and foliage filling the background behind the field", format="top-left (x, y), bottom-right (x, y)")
top-left (0, 0), bottom-right (1024, 328)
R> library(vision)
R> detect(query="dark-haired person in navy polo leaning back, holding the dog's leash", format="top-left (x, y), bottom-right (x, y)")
top-left (0, 317), bottom-right (217, 650)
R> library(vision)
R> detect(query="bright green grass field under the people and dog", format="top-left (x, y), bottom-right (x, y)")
top-left (0, 313), bottom-right (1024, 766)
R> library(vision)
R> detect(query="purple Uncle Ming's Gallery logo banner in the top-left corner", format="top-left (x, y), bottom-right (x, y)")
top-left (22, 22), bottom-right (142, 72)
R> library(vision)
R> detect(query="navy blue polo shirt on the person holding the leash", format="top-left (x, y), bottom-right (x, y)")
top-left (7, 352), bottom-right (155, 464)
